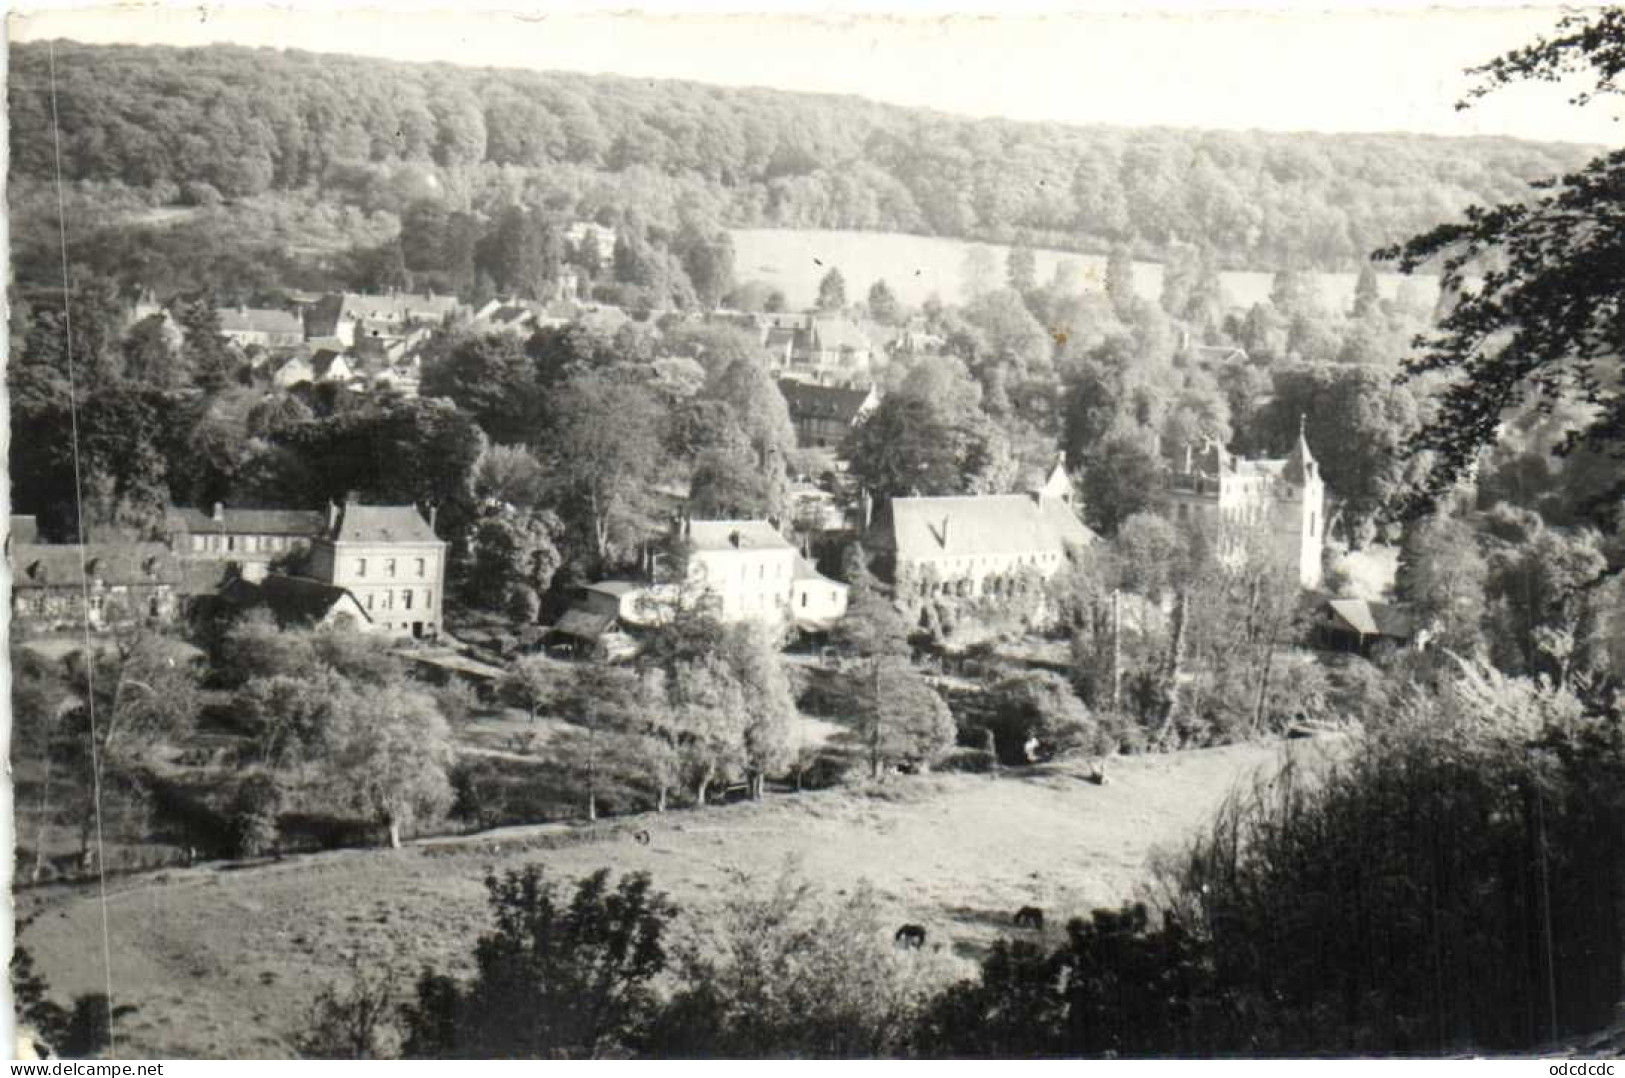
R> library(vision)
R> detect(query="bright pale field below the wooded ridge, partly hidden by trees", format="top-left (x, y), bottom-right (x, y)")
top-left (730, 228), bottom-right (1438, 311)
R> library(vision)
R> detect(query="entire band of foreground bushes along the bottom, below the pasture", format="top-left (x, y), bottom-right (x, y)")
top-left (299, 672), bottom-right (1625, 1057)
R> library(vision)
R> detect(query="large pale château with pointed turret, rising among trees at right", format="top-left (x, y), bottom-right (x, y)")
top-left (1168, 428), bottom-right (1326, 587)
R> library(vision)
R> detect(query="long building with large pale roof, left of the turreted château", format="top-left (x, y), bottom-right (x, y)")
top-left (869, 457), bottom-right (1095, 598)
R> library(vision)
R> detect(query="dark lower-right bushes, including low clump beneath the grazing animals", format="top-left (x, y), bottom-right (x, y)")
top-left (920, 672), bottom-right (1625, 1057)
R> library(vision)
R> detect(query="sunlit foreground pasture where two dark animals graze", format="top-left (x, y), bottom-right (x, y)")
top-left (18, 741), bottom-right (1323, 1057)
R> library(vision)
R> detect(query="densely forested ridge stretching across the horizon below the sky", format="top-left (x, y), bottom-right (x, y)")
top-left (10, 42), bottom-right (1589, 270)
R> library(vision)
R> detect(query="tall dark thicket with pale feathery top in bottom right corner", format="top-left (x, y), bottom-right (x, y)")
top-left (1167, 673), bottom-right (1625, 1055)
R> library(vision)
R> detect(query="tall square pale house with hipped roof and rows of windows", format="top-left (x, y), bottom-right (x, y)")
top-left (307, 502), bottom-right (445, 637)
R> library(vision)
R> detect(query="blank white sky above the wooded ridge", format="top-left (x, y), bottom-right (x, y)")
top-left (8, 0), bottom-right (1622, 145)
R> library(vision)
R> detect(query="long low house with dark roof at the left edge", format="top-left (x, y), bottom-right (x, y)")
top-left (7, 543), bottom-right (182, 632)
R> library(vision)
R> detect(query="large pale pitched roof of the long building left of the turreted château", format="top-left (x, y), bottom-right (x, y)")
top-left (889, 494), bottom-right (1095, 559)
